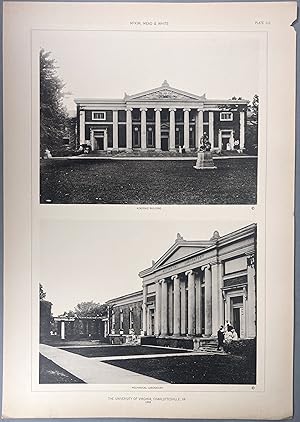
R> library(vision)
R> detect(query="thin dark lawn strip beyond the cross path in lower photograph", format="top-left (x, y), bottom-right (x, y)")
top-left (63, 346), bottom-right (186, 358)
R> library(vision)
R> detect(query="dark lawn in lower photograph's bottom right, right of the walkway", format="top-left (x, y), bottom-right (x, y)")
top-left (105, 355), bottom-right (256, 385)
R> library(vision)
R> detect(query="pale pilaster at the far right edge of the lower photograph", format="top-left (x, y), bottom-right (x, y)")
top-left (246, 254), bottom-right (256, 337)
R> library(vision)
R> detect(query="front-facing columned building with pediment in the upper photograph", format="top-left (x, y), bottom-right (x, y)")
top-left (75, 81), bottom-right (248, 152)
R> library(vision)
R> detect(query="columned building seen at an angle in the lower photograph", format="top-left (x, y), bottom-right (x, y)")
top-left (105, 224), bottom-right (256, 341)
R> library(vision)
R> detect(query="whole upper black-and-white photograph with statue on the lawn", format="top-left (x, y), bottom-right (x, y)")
top-left (38, 31), bottom-right (263, 205)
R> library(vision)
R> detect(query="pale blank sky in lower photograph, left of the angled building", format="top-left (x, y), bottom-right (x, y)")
top-left (39, 219), bottom-right (251, 315)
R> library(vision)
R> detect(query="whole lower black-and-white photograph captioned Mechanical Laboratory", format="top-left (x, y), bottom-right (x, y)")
top-left (39, 220), bottom-right (257, 385)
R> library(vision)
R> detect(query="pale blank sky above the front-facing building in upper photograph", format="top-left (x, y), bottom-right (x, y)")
top-left (37, 31), bottom-right (262, 110)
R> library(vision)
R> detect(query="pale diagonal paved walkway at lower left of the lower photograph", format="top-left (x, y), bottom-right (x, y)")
top-left (40, 344), bottom-right (166, 384)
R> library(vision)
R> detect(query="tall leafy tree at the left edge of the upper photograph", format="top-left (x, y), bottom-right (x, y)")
top-left (40, 49), bottom-right (68, 154)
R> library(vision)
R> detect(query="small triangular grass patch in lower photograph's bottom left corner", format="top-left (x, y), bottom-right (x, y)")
top-left (39, 354), bottom-right (84, 384)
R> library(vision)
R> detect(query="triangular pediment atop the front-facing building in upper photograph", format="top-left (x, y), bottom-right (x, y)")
top-left (125, 81), bottom-right (205, 102)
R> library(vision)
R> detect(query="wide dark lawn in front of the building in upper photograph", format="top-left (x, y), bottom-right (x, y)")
top-left (40, 158), bottom-right (257, 205)
